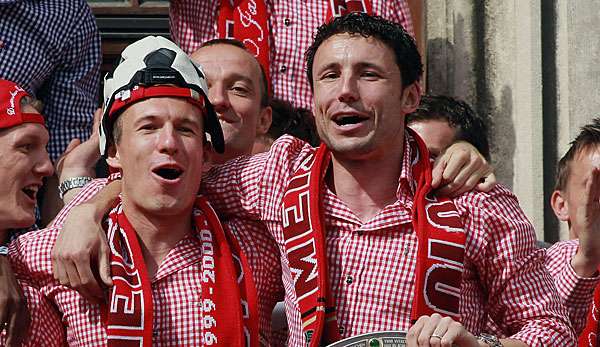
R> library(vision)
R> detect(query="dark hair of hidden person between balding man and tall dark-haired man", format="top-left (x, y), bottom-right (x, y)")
top-left (267, 99), bottom-right (320, 146)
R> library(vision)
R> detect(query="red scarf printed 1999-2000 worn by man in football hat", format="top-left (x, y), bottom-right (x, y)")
top-left (102, 196), bottom-right (258, 347)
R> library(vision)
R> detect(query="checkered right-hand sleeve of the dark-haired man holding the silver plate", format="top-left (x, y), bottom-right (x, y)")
top-left (465, 187), bottom-right (575, 346)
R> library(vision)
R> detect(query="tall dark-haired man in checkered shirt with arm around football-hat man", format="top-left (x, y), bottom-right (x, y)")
top-left (203, 14), bottom-right (573, 346)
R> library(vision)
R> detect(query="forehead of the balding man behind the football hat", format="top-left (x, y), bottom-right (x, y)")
top-left (192, 44), bottom-right (261, 83)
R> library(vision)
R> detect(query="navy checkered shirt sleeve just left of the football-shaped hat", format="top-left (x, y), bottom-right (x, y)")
top-left (39, 1), bottom-right (101, 160)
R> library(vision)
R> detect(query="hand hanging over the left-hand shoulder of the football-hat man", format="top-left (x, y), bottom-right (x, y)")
top-left (52, 203), bottom-right (112, 303)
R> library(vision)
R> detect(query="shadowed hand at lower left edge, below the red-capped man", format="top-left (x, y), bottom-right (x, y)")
top-left (0, 256), bottom-right (29, 346)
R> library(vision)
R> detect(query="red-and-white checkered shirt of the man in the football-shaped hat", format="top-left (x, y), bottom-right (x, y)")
top-left (10, 179), bottom-right (283, 346)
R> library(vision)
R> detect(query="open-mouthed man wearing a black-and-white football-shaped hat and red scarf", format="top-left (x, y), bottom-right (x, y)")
top-left (4, 37), bottom-right (258, 346)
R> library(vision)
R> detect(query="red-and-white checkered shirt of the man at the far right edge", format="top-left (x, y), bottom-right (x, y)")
top-left (546, 240), bottom-right (600, 335)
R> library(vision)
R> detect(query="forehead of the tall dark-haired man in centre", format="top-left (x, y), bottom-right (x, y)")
top-left (313, 33), bottom-right (398, 69)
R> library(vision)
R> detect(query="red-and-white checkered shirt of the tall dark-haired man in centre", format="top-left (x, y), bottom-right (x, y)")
top-left (202, 135), bottom-right (575, 346)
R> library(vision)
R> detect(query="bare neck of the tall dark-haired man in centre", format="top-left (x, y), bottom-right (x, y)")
top-left (328, 142), bottom-right (404, 222)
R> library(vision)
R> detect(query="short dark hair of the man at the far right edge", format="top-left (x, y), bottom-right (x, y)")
top-left (554, 117), bottom-right (600, 191)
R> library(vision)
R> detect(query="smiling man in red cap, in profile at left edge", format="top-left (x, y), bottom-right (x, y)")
top-left (0, 79), bottom-right (54, 345)
